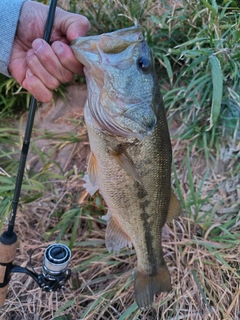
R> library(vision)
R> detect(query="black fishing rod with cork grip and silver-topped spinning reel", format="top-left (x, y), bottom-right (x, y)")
top-left (0, 0), bottom-right (71, 307)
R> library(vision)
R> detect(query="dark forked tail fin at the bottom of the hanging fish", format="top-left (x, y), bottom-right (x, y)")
top-left (134, 264), bottom-right (172, 309)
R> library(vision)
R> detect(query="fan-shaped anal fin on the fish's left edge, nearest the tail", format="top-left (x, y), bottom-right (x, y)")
top-left (105, 212), bottom-right (132, 254)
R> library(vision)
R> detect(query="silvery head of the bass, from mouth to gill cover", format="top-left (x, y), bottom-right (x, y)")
top-left (71, 26), bottom-right (159, 140)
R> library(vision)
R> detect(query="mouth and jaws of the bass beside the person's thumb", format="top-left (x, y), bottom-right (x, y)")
top-left (70, 26), bottom-right (144, 98)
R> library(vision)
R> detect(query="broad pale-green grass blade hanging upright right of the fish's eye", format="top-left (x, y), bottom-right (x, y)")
top-left (207, 56), bottom-right (223, 131)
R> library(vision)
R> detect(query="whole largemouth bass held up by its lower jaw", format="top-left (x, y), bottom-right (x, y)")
top-left (71, 25), bottom-right (181, 309)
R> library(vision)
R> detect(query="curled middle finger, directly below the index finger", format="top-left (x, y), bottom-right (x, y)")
top-left (29, 39), bottom-right (73, 84)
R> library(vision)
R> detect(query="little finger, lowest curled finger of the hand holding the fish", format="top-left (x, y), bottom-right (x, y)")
top-left (22, 69), bottom-right (53, 102)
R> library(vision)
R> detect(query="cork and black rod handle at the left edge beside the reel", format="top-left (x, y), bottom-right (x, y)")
top-left (0, 231), bottom-right (17, 307)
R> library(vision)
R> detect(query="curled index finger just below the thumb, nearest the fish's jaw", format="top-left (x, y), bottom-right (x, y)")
top-left (52, 41), bottom-right (83, 74)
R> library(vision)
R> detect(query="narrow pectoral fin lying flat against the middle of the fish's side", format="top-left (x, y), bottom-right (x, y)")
top-left (110, 149), bottom-right (142, 185)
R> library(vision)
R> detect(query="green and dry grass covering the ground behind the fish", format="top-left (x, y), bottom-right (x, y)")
top-left (0, 0), bottom-right (240, 320)
